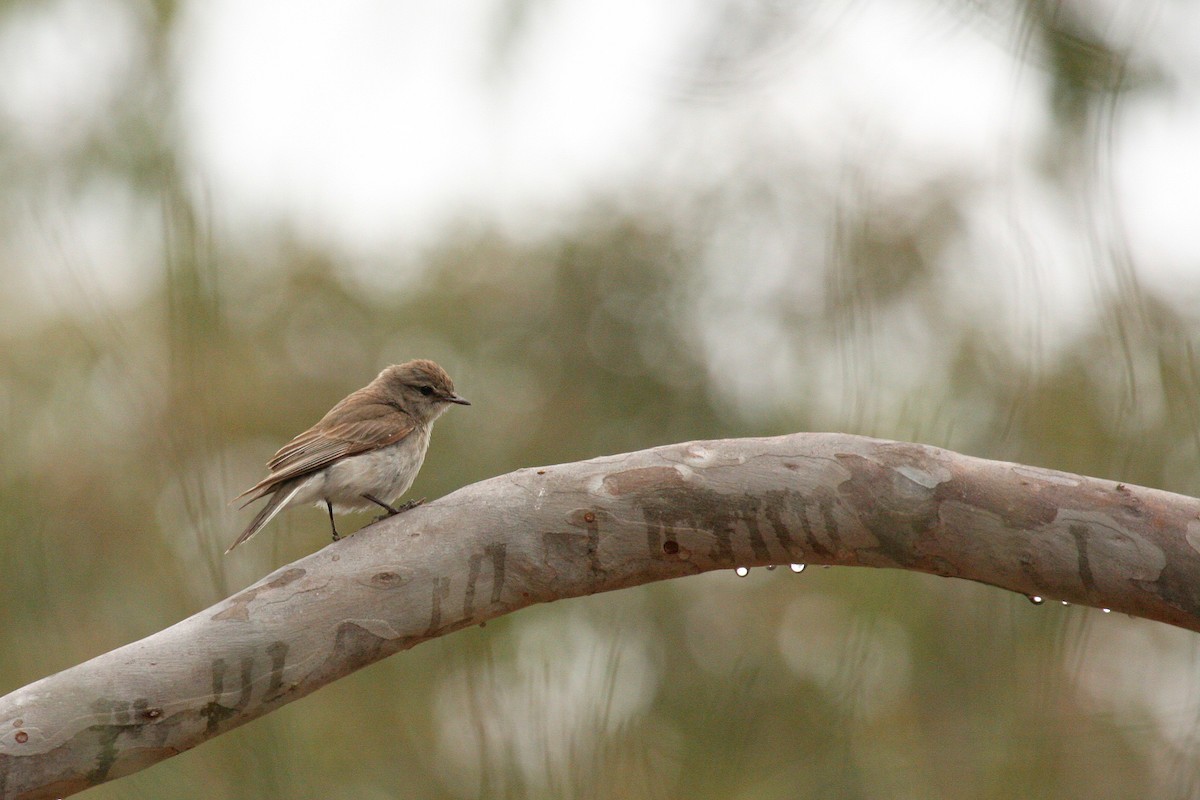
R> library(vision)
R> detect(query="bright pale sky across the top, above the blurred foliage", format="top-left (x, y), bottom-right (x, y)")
top-left (0, 0), bottom-right (1200, 340)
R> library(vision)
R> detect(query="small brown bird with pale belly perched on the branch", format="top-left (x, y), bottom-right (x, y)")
top-left (226, 359), bottom-right (470, 553)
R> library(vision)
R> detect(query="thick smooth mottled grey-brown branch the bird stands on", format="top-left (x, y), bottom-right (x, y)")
top-left (0, 433), bottom-right (1200, 799)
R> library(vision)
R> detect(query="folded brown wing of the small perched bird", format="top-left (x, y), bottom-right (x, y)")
top-left (234, 401), bottom-right (416, 505)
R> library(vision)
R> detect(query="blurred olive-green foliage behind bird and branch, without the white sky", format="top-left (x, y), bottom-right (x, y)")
top-left (0, 0), bottom-right (1200, 800)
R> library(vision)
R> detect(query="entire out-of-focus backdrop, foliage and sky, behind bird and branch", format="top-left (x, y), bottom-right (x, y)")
top-left (0, 0), bottom-right (1200, 799)
